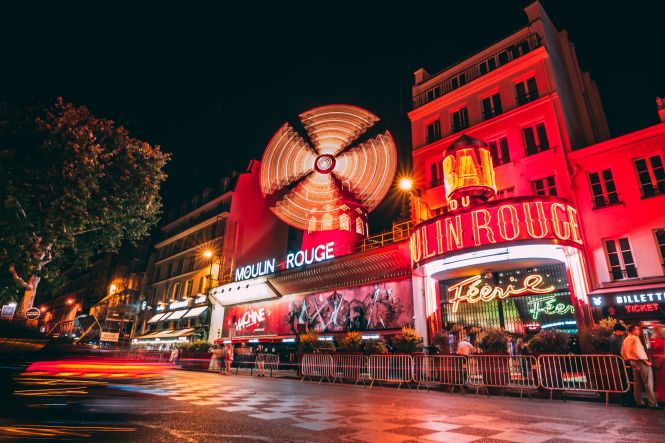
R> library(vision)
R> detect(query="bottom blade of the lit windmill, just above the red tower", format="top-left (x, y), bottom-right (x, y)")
top-left (274, 172), bottom-right (342, 231)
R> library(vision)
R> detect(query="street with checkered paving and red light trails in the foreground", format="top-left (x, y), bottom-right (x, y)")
top-left (0, 369), bottom-right (665, 443)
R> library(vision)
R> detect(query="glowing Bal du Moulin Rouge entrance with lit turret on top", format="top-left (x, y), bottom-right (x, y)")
top-left (411, 138), bottom-right (592, 346)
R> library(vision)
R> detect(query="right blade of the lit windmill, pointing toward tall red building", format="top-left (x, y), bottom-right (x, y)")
top-left (333, 131), bottom-right (397, 211)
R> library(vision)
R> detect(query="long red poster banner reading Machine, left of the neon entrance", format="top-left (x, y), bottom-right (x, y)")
top-left (224, 278), bottom-right (413, 336)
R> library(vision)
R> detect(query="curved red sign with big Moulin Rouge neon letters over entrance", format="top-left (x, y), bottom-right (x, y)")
top-left (411, 196), bottom-right (582, 265)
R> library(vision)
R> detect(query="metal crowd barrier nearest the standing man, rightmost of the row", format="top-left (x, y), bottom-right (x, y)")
top-left (538, 354), bottom-right (630, 404)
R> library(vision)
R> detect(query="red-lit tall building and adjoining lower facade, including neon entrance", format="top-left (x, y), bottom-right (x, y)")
top-left (409, 2), bottom-right (665, 344)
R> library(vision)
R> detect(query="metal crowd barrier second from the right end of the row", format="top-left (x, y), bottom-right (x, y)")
top-left (467, 355), bottom-right (538, 396)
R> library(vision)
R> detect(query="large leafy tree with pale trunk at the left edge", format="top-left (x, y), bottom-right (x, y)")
top-left (0, 98), bottom-right (170, 316)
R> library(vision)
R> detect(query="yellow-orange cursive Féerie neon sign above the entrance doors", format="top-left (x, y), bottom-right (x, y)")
top-left (448, 274), bottom-right (556, 312)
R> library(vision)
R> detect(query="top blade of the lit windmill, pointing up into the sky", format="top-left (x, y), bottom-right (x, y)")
top-left (300, 105), bottom-right (379, 156)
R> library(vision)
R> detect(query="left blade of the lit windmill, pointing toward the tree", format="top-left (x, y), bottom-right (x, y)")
top-left (261, 123), bottom-right (316, 195)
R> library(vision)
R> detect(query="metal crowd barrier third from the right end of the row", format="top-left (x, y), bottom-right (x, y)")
top-left (413, 355), bottom-right (467, 392)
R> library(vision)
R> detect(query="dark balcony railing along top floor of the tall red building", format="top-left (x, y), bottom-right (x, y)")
top-left (413, 34), bottom-right (542, 109)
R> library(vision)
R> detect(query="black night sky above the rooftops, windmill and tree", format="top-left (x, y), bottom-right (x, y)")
top-left (0, 0), bottom-right (665, 231)
